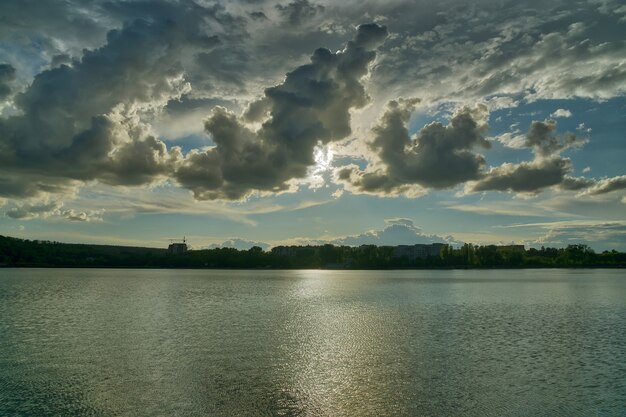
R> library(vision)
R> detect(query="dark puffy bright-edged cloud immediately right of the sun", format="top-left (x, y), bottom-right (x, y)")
top-left (336, 100), bottom-right (489, 194)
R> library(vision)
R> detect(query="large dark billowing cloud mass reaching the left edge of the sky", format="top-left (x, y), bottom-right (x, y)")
top-left (0, 8), bottom-right (223, 197)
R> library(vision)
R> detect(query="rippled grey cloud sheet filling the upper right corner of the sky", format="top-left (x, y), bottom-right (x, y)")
top-left (373, 1), bottom-right (626, 102)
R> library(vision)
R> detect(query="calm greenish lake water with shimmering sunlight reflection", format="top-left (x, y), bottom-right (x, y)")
top-left (0, 269), bottom-right (626, 416)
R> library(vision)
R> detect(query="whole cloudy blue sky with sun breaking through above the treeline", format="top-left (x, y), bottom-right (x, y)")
top-left (0, 0), bottom-right (626, 251)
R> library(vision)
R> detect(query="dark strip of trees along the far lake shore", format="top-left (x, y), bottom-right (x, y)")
top-left (0, 236), bottom-right (626, 269)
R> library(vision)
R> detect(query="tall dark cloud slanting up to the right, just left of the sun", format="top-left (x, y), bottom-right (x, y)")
top-left (175, 24), bottom-right (387, 199)
